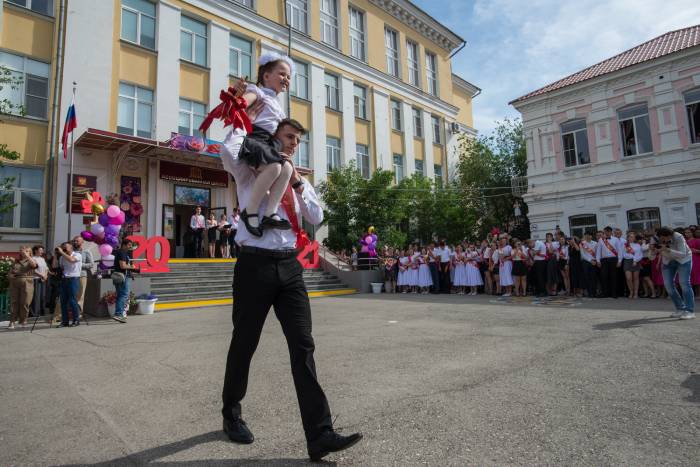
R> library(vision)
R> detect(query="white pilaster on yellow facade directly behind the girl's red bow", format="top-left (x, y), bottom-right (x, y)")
top-left (207, 21), bottom-right (230, 141)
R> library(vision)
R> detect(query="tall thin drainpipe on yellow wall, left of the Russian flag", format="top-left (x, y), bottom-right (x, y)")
top-left (46, 0), bottom-right (66, 251)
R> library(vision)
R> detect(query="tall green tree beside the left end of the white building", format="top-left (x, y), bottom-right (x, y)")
top-left (457, 119), bottom-right (529, 238)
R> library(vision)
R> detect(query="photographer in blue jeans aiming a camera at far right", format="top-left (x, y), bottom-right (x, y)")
top-left (656, 227), bottom-right (695, 319)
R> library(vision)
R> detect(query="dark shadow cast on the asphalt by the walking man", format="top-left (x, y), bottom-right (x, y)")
top-left (58, 430), bottom-right (336, 467)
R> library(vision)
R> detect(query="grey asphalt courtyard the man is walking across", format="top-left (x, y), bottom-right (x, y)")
top-left (0, 295), bottom-right (700, 466)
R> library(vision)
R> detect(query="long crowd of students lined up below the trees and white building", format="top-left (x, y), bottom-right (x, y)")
top-left (358, 226), bottom-right (700, 318)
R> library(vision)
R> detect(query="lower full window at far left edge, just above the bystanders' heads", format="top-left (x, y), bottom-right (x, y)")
top-left (0, 165), bottom-right (44, 229)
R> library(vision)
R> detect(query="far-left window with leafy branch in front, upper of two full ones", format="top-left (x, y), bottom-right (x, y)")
top-left (0, 52), bottom-right (50, 119)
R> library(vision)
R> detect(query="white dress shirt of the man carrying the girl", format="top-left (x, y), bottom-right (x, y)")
top-left (221, 128), bottom-right (323, 250)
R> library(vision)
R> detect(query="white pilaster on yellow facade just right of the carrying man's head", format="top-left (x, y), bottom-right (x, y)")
top-left (309, 63), bottom-right (327, 186)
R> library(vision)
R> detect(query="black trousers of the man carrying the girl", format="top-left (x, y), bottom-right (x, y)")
top-left (222, 251), bottom-right (333, 441)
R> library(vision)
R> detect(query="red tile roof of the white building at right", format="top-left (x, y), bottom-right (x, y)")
top-left (510, 24), bottom-right (700, 104)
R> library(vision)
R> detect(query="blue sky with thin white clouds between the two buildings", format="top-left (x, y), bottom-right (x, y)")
top-left (412, 0), bottom-right (700, 134)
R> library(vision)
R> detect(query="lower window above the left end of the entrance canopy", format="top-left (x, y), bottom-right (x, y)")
top-left (117, 83), bottom-right (153, 138)
